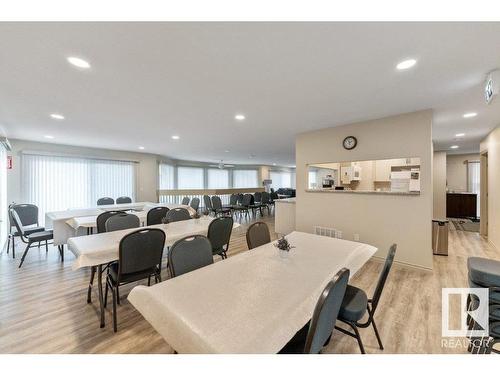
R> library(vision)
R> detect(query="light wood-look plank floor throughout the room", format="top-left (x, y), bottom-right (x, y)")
top-left (0, 217), bottom-right (500, 353)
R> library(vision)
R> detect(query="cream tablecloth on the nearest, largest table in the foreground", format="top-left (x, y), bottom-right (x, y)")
top-left (128, 232), bottom-right (377, 353)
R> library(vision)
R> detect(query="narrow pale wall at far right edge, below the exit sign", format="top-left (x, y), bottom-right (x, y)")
top-left (480, 127), bottom-right (500, 249)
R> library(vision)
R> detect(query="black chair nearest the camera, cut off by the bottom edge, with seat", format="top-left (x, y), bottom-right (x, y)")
top-left (279, 268), bottom-right (349, 354)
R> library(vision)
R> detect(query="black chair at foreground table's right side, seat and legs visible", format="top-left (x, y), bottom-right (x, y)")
top-left (335, 244), bottom-right (397, 354)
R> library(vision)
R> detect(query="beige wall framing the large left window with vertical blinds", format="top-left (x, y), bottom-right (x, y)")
top-left (7, 139), bottom-right (158, 203)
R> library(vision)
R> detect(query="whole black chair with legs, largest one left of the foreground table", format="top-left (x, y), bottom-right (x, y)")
top-left (104, 229), bottom-right (165, 332)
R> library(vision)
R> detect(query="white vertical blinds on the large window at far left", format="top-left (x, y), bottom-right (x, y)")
top-left (21, 154), bottom-right (136, 223)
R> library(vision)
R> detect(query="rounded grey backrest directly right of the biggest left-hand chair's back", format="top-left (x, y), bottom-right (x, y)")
top-left (168, 235), bottom-right (214, 277)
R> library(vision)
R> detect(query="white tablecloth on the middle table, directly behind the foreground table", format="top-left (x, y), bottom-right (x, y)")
top-left (68, 217), bottom-right (240, 269)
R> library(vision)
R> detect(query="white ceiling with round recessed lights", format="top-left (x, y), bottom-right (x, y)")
top-left (0, 23), bottom-right (500, 165)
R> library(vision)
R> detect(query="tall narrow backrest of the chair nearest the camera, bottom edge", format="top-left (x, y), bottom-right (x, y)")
top-left (304, 268), bottom-right (349, 354)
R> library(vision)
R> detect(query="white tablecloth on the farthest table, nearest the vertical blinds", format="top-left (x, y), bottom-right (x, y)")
top-left (45, 202), bottom-right (195, 245)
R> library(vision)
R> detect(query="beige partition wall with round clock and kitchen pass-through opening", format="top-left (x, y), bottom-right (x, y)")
top-left (296, 110), bottom-right (433, 269)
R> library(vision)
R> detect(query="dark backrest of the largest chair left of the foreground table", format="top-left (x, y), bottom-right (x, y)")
top-left (118, 228), bottom-right (165, 278)
